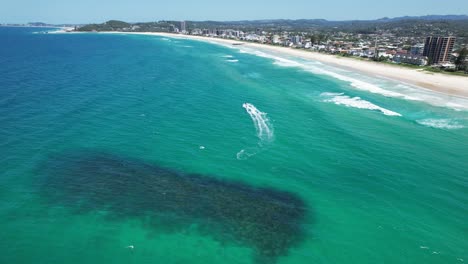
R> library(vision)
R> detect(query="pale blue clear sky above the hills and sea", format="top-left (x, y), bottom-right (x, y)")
top-left (0, 0), bottom-right (468, 23)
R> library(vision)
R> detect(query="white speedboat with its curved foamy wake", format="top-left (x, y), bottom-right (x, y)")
top-left (237, 103), bottom-right (274, 160)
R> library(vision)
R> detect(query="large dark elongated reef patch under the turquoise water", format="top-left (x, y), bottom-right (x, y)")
top-left (39, 151), bottom-right (306, 262)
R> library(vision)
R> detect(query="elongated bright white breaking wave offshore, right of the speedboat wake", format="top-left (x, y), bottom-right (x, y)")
top-left (320, 93), bottom-right (401, 116)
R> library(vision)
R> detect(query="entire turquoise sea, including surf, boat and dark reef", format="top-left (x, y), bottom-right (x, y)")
top-left (0, 28), bottom-right (468, 263)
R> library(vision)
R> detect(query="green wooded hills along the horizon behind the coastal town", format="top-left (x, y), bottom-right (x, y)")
top-left (74, 15), bottom-right (468, 43)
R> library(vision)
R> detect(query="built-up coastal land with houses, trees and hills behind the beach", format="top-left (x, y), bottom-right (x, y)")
top-left (76, 15), bottom-right (468, 76)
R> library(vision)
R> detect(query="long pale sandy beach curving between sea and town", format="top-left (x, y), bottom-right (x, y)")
top-left (99, 32), bottom-right (468, 99)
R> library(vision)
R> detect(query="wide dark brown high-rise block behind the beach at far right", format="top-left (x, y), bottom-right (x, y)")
top-left (423, 37), bottom-right (455, 64)
